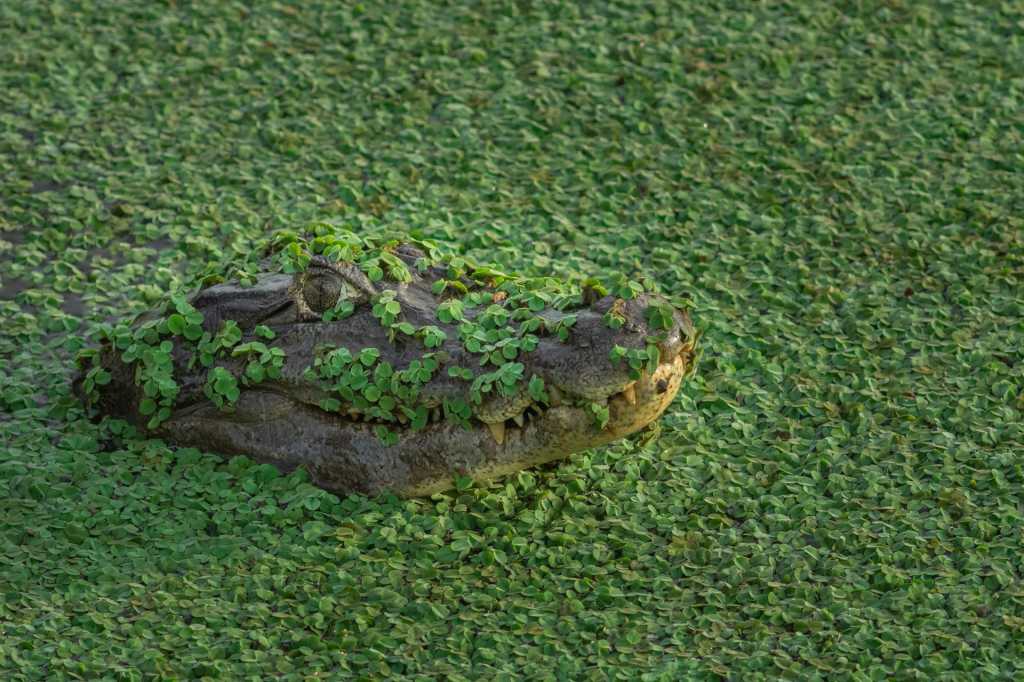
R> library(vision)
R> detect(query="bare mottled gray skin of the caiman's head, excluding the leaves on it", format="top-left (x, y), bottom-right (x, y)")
top-left (83, 246), bottom-right (694, 496)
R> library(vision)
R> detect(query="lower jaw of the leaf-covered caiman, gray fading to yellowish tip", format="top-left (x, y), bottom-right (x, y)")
top-left (155, 356), bottom-right (688, 497)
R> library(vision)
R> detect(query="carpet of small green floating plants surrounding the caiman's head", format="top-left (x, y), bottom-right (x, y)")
top-left (0, 0), bottom-right (1024, 680)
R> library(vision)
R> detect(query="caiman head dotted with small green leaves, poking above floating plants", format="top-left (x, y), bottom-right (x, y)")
top-left (74, 223), bottom-right (698, 497)
